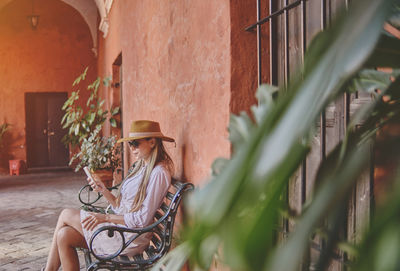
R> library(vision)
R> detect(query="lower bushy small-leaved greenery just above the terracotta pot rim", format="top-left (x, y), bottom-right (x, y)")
top-left (70, 127), bottom-right (121, 171)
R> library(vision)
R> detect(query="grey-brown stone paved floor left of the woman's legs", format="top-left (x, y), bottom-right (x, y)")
top-left (0, 171), bottom-right (86, 271)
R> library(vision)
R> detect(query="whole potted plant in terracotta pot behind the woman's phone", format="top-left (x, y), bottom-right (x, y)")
top-left (61, 68), bottom-right (121, 186)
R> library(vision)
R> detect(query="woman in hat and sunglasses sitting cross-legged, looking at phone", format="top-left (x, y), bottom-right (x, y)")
top-left (42, 120), bottom-right (175, 271)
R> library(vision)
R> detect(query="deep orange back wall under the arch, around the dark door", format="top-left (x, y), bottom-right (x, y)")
top-left (0, 0), bottom-right (97, 168)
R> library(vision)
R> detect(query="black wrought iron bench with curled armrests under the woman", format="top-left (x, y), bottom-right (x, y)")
top-left (79, 179), bottom-right (194, 271)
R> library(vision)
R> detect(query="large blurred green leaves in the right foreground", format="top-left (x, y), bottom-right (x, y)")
top-left (155, 0), bottom-right (400, 271)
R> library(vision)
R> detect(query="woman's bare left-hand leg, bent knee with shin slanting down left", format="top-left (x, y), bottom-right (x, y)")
top-left (45, 209), bottom-right (86, 271)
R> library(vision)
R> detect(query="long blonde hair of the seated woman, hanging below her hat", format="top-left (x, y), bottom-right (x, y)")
top-left (117, 138), bottom-right (174, 212)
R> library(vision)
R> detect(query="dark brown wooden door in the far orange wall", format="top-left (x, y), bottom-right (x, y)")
top-left (25, 92), bottom-right (69, 168)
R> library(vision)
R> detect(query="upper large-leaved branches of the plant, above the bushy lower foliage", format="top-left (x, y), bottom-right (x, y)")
top-left (61, 68), bottom-right (120, 149)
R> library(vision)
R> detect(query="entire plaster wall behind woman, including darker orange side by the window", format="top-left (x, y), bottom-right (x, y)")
top-left (98, 0), bottom-right (257, 187)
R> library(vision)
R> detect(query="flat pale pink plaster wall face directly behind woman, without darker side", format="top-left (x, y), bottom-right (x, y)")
top-left (110, 0), bottom-right (230, 184)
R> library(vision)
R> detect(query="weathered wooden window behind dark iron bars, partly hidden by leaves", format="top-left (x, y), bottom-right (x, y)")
top-left (246, 0), bottom-right (373, 270)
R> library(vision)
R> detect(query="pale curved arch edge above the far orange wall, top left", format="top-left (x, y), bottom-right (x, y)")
top-left (0, 0), bottom-right (98, 54)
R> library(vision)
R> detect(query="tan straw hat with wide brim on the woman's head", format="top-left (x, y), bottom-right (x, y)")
top-left (117, 120), bottom-right (175, 143)
